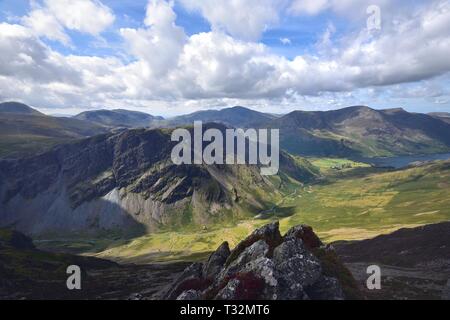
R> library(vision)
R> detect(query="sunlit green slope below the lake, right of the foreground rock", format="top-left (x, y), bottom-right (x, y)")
top-left (283, 162), bottom-right (450, 242)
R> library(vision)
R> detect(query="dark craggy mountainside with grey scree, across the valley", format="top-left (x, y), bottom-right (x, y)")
top-left (0, 130), bottom-right (314, 235)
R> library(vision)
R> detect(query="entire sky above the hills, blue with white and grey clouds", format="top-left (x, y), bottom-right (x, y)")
top-left (0, 0), bottom-right (450, 116)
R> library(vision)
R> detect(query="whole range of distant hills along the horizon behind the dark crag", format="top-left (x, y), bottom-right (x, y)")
top-left (0, 103), bottom-right (450, 157)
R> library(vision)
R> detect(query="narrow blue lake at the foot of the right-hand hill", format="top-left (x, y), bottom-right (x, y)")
top-left (352, 153), bottom-right (450, 169)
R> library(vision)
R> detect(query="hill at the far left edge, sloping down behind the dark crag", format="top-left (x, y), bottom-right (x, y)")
top-left (0, 102), bottom-right (109, 158)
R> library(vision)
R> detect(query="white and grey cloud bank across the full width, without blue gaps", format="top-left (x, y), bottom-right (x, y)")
top-left (0, 0), bottom-right (450, 111)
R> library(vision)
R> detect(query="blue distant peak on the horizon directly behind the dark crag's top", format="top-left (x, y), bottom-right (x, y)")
top-left (160, 107), bottom-right (276, 128)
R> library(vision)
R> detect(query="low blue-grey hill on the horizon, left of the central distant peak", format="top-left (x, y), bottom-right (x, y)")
top-left (74, 109), bottom-right (164, 128)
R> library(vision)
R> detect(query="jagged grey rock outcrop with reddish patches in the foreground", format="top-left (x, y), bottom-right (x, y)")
top-left (164, 222), bottom-right (361, 300)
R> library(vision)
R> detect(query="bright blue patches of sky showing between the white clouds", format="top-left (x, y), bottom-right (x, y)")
top-left (0, 0), bottom-right (330, 59)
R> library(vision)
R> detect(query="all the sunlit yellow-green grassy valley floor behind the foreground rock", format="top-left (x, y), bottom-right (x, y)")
top-left (89, 159), bottom-right (450, 262)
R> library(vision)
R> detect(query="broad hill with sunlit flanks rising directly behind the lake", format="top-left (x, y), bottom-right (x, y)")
top-left (266, 106), bottom-right (450, 157)
